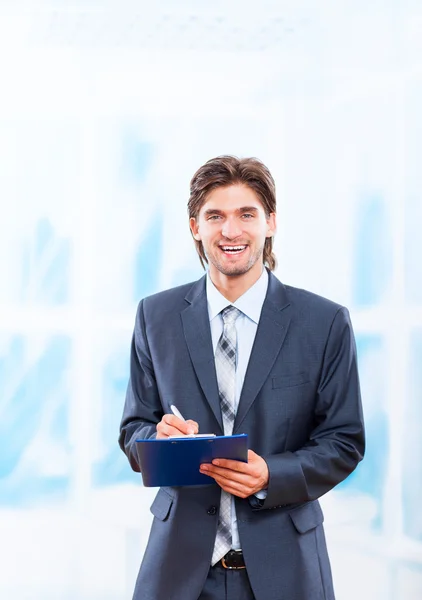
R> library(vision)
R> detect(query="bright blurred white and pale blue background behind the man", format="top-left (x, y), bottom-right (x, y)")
top-left (0, 0), bottom-right (422, 600)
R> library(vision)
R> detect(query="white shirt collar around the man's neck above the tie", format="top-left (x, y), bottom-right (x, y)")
top-left (207, 268), bottom-right (268, 324)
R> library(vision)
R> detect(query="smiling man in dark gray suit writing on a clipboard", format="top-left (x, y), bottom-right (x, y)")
top-left (120, 156), bottom-right (364, 600)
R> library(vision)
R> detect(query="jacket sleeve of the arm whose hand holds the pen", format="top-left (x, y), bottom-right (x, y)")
top-left (119, 300), bottom-right (164, 472)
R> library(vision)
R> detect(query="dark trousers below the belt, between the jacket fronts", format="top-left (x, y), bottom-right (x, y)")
top-left (198, 565), bottom-right (255, 600)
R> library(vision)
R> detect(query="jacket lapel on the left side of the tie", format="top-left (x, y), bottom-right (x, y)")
top-left (181, 277), bottom-right (223, 433)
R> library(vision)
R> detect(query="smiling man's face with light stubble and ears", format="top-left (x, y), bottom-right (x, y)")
top-left (190, 184), bottom-right (275, 276)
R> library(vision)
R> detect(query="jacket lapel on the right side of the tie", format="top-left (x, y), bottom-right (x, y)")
top-left (233, 273), bottom-right (291, 433)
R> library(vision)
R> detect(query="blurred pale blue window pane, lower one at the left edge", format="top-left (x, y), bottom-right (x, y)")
top-left (0, 336), bottom-right (70, 506)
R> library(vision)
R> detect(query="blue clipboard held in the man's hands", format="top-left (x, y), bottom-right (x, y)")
top-left (136, 433), bottom-right (248, 487)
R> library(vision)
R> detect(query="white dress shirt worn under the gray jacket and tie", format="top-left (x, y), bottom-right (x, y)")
top-left (207, 269), bottom-right (268, 550)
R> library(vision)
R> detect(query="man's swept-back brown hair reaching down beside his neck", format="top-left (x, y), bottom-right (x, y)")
top-left (188, 156), bottom-right (277, 271)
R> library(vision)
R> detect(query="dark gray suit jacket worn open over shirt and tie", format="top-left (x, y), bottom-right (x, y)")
top-left (119, 274), bottom-right (364, 600)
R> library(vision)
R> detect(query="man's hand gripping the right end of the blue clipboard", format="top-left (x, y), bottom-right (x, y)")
top-left (200, 450), bottom-right (269, 498)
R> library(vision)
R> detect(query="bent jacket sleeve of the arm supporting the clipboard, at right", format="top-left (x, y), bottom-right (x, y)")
top-left (251, 308), bottom-right (365, 509)
